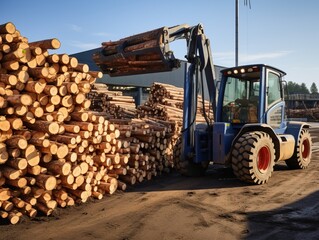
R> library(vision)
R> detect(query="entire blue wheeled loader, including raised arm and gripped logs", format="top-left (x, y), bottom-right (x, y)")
top-left (93, 24), bottom-right (312, 184)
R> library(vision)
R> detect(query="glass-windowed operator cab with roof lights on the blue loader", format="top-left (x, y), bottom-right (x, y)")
top-left (216, 64), bottom-right (285, 129)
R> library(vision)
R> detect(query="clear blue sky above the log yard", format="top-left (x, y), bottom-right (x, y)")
top-left (0, 0), bottom-right (319, 87)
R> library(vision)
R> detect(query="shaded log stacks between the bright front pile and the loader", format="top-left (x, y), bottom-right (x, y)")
top-left (87, 82), bottom-right (213, 177)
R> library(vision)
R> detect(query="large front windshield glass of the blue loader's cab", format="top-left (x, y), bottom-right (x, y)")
top-left (222, 74), bottom-right (260, 123)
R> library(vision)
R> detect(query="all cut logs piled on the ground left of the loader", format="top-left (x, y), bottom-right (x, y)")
top-left (0, 23), bottom-right (215, 224)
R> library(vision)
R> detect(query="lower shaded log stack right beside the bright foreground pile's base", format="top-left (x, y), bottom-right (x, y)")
top-left (110, 118), bottom-right (173, 185)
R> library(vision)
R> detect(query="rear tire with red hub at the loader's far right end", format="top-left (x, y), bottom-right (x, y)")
top-left (286, 128), bottom-right (312, 169)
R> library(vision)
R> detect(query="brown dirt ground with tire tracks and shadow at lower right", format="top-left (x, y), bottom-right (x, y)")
top-left (0, 125), bottom-right (319, 240)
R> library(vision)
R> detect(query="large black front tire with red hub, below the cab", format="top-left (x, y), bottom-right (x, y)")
top-left (231, 131), bottom-right (275, 184)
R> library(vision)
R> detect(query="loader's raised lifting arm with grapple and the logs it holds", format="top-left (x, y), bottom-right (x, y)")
top-left (93, 24), bottom-right (216, 163)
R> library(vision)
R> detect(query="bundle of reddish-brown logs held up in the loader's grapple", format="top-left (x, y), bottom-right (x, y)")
top-left (93, 27), bottom-right (180, 76)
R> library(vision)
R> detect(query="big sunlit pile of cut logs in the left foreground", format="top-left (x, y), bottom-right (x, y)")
top-left (0, 23), bottom-right (134, 224)
